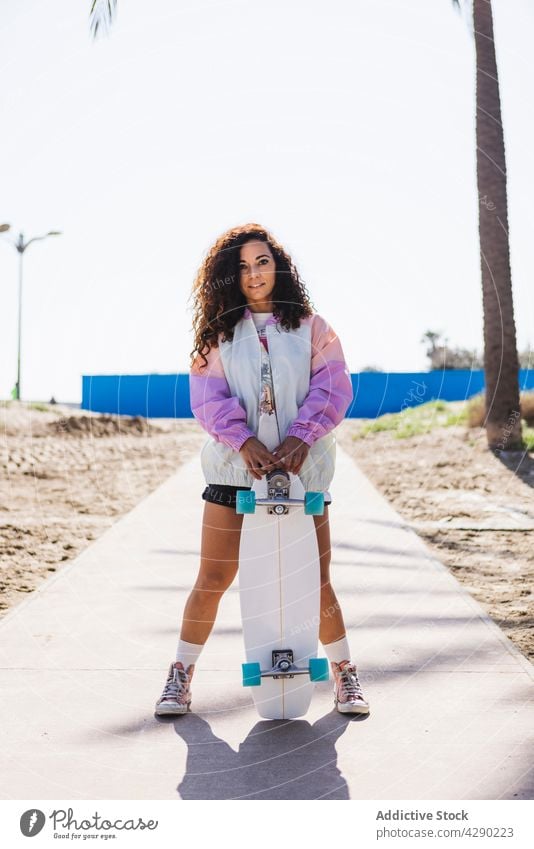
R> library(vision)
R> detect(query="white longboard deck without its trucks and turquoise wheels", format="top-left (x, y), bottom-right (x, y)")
top-left (239, 410), bottom-right (321, 719)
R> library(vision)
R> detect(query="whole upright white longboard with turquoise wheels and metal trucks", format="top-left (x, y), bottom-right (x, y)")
top-left (236, 416), bottom-right (328, 719)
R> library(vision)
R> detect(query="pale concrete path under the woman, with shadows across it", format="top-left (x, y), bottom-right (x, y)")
top-left (0, 446), bottom-right (534, 800)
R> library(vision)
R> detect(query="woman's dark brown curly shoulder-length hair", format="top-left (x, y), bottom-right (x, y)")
top-left (190, 224), bottom-right (313, 368)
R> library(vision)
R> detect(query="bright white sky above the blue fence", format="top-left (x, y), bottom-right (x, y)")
top-left (0, 0), bottom-right (534, 402)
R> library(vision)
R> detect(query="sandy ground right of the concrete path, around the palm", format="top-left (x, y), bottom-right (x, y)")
top-left (336, 419), bottom-right (534, 661)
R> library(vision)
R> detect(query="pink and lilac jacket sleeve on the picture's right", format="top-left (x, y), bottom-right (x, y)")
top-left (287, 314), bottom-right (354, 446)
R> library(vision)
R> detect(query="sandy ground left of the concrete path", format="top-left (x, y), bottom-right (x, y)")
top-left (0, 402), bottom-right (206, 616)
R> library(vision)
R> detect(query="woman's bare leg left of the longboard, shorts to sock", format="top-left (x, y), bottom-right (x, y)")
top-left (180, 501), bottom-right (243, 646)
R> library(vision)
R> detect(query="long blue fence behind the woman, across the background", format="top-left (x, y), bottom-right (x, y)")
top-left (81, 369), bottom-right (534, 418)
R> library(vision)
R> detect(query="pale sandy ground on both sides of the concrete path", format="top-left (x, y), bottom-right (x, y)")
top-left (0, 402), bottom-right (534, 660)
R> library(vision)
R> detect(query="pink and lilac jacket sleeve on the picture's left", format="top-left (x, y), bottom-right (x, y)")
top-left (189, 347), bottom-right (255, 451)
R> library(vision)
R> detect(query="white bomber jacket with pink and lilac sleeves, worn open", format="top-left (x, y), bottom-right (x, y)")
top-left (189, 307), bottom-right (353, 492)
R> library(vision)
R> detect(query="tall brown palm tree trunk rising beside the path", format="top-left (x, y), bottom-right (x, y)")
top-left (473, 0), bottom-right (522, 451)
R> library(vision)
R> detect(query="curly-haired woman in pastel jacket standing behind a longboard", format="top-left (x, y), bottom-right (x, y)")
top-left (156, 224), bottom-right (369, 715)
